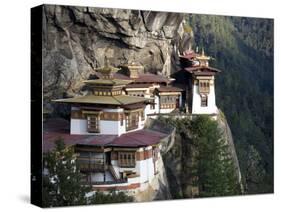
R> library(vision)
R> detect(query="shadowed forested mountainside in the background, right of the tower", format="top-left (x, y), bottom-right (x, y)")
top-left (187, 15), bottom-right (273, 193)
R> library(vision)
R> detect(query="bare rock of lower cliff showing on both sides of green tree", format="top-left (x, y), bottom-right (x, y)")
top-left (158, 113), bottom-right (243, 199)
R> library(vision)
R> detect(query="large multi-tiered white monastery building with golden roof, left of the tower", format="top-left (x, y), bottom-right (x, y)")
top-left (54, 64), bottom-right (182, 190)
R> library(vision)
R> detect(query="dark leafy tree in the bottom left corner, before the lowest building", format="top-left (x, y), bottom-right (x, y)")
top-left (43, 140), bottom-right (90, 207)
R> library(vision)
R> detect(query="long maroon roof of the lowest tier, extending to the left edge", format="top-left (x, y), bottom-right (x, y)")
top-left (43, 119), bottom-right (167, 152)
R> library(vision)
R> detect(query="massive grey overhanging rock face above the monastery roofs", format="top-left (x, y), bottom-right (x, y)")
top-left (43, 5), bottom-right (189, 107)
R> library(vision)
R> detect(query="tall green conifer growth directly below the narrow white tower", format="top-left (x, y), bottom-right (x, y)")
top-left (191, 116), bottom-right (241, 197)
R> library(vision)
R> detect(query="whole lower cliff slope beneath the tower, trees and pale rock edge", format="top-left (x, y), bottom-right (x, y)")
top-left (151, 113), bottom-right (244, 199)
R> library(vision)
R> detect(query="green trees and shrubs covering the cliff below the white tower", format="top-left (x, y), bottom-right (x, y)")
top-left (154, 116), bottom-right (241, 198)
